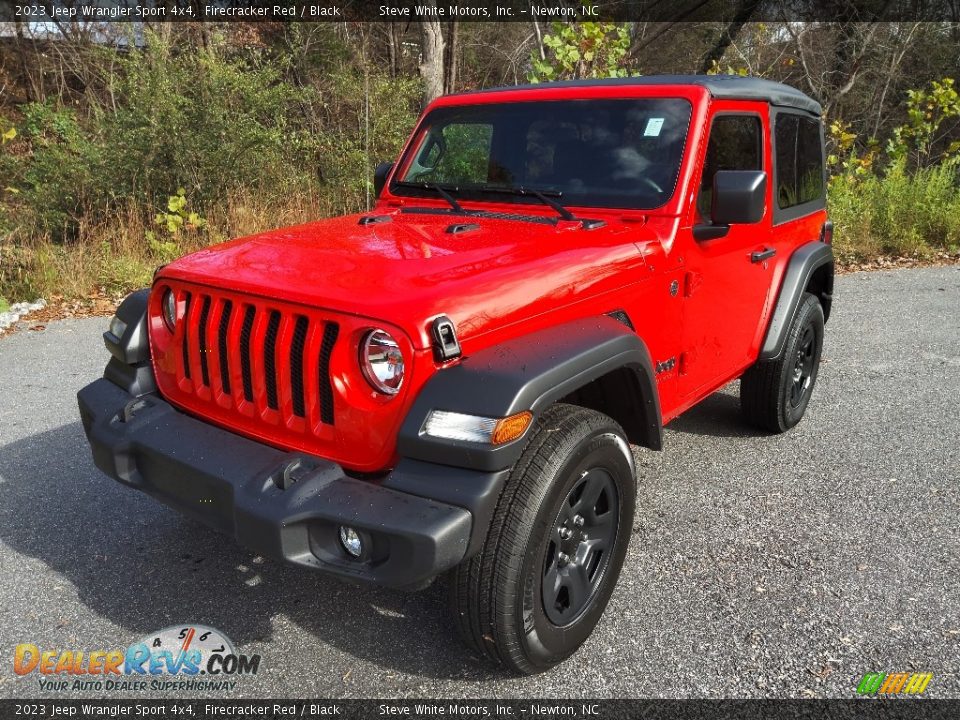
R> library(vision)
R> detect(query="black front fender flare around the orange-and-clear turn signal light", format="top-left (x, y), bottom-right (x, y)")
top-left (397, 315), bottom-right (662, 472)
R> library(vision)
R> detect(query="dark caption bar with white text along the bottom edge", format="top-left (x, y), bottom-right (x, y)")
top-left (0, 697), bottom-right (960, 720)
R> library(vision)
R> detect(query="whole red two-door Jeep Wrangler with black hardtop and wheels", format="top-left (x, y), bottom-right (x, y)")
top-left (79, 76), bottom-right (833, 673)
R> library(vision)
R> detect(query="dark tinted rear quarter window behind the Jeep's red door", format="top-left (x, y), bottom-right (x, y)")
top-left (774, 113), bottom-right (823, 210)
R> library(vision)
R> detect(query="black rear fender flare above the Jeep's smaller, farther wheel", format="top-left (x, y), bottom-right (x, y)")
top-left (760, 240), bottom-right (833, 360)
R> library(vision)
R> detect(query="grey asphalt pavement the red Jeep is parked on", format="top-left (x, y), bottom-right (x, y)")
top-left (0, 267), bottom-right (960, 698)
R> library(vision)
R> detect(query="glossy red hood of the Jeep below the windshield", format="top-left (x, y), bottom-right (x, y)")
top-left (158, 212), bottom-right (653, 348)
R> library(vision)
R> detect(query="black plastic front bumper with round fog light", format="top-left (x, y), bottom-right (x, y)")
top-left (78, 379), bottom-right (474, 588)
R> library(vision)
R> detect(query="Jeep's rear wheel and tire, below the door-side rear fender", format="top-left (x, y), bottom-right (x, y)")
top-left (740, 293), bottom-right (823, 433)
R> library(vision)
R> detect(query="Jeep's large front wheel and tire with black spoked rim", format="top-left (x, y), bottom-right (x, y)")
top-left (449, 404), bottom-right (636, 675)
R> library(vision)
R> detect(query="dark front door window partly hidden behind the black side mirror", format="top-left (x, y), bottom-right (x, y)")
top-left (697, 115), bottom-right (763, 221)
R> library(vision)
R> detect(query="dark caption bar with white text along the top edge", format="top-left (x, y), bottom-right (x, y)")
top-left (0, 0), bottom-right (960, 23)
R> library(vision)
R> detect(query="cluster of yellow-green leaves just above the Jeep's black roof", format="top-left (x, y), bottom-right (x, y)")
top-left (527, 22), bottom-right (630, 83)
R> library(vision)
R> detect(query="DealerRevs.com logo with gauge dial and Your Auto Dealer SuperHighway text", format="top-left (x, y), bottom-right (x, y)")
top-left (13, 625), bottom-right (260, 692)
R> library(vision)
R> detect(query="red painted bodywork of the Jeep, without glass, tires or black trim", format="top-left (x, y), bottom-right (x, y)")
top-left (148, 85), bottom-right (826, 472)
